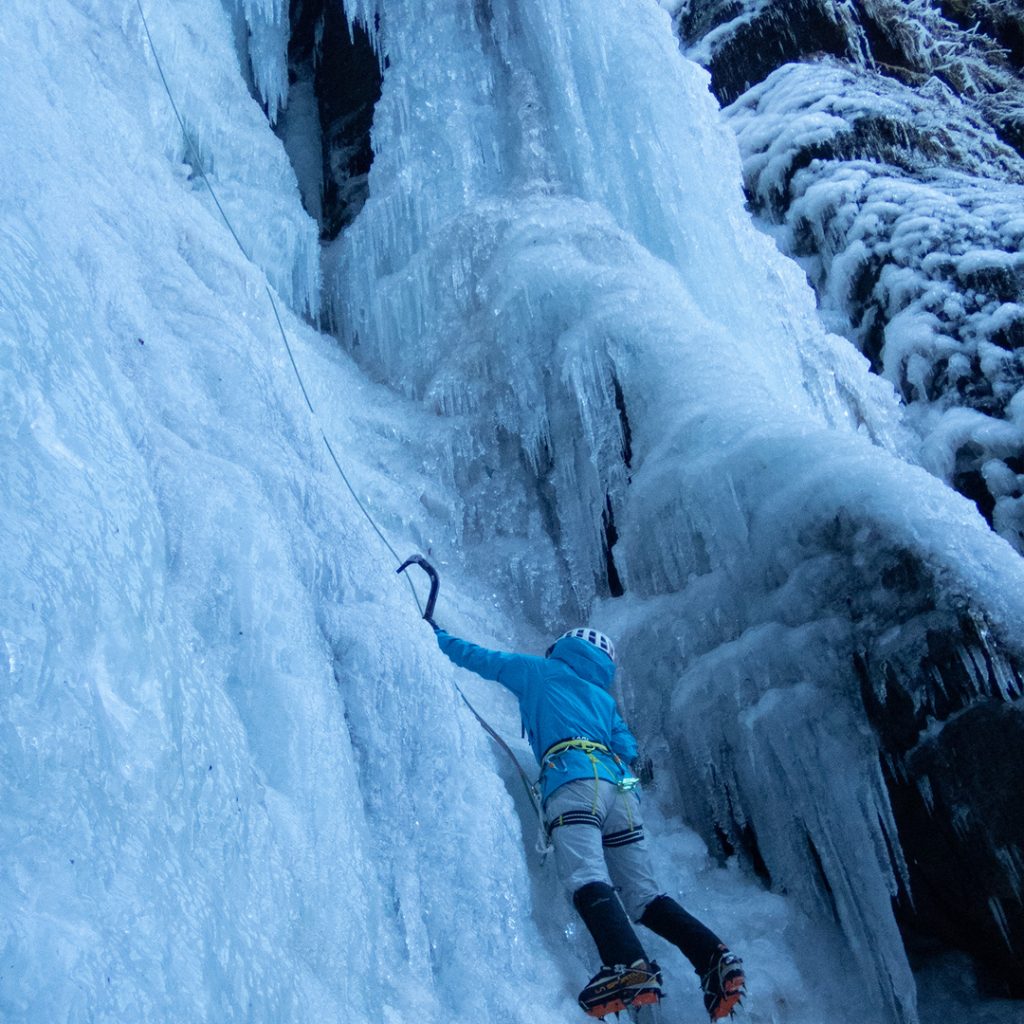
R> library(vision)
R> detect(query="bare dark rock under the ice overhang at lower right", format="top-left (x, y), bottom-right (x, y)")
top-left (854, 608), bottom-right (1024, 997)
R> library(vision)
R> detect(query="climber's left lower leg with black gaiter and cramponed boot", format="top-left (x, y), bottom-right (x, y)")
top-left (572, 882), bottom-right (662, 1017)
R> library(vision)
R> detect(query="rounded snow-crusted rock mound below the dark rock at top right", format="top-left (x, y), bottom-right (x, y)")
top-left (728, 62), bottom-right (1024, 551)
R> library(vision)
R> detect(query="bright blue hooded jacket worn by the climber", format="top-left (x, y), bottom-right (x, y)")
top-left (437, 630), bottom-right (637, 800)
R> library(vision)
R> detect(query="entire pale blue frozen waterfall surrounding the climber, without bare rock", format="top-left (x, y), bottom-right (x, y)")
top-left (0, 0), bottom-right (1024, 1024)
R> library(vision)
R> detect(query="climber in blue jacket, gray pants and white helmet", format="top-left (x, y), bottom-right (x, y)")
top-left (431, 622), bottom-right (745, 1021)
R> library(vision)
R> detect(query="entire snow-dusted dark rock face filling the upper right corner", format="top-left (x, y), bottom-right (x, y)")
top-left (678, 0), bottom-right (1024, 553)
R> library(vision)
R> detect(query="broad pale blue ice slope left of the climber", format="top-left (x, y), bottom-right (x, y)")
top-left (0, 0), bottom-right (573, 1024)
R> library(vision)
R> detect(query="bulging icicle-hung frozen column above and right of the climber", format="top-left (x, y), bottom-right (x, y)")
top-left (328, 0), bottom-right (1024, 1021)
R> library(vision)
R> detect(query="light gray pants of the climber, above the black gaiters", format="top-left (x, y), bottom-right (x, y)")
top-left (544, 778), bottom-right (662, 921)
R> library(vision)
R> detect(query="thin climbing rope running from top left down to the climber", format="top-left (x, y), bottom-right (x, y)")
top-left (142, 0), bottom-right (547, 854)
